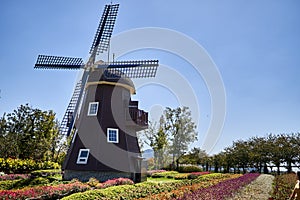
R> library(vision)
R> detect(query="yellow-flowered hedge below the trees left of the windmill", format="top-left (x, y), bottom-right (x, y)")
top-left (0, 158), bottom-right (60, 174)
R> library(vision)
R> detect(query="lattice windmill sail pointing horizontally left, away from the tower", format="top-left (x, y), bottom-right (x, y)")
top-left (34, 55), bottom-right (84, 69)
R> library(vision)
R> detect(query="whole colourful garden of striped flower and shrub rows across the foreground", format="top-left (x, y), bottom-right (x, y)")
top-left (0, 170), bottom-right (295, 200)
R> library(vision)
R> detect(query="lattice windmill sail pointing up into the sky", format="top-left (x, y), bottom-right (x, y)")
top-left (90, 4), bottom-right (119, 55)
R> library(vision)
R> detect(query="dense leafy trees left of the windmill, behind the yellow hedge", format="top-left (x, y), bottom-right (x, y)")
top-left (0, 104), bottom-right (66, 161)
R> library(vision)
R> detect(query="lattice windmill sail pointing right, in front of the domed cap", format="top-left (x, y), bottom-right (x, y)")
top-left (97, 60), bottom-right (158, 78)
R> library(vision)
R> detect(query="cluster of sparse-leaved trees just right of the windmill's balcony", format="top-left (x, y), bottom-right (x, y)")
top-left (139, 107), bottom-right (201, 169)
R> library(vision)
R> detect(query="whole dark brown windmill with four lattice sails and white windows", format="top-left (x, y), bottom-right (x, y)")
top-left (35, 4), bottom-right (158, 182)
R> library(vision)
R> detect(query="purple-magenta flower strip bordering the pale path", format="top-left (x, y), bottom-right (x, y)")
top-left (178, 173), bottom-right (259, 200)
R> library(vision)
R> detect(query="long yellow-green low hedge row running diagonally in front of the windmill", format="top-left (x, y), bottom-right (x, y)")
top-left (63, 174), bottom-right (234, 200)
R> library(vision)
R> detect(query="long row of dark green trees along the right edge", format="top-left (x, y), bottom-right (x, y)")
top-left (211, 133), bottom-right (300, 174)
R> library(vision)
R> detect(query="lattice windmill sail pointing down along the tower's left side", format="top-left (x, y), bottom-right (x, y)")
top-left (59, 81), bottom-right (82, 136)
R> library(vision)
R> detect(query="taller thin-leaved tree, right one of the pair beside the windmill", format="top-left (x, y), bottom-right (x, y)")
top-left (164, 107), bottom-right (197, 167)
